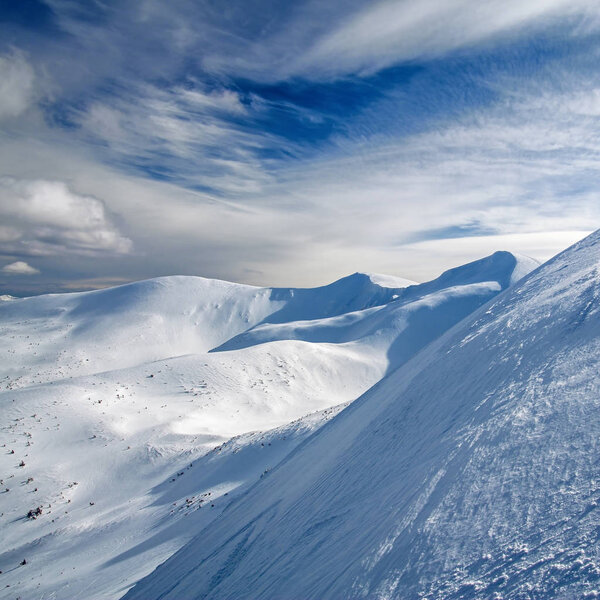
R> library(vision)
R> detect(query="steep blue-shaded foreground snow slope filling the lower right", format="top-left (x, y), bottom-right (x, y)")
top-left (125, 233), bottom-right (600, 600)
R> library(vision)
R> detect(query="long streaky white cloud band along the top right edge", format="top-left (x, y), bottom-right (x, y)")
top-left (142, 0), bottom-right (600, 81)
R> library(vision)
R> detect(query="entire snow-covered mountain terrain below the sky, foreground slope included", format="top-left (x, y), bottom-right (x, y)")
top-left (0, 241), bottom-right (600, 600)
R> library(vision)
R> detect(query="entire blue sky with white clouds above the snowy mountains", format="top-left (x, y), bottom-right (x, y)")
top-left (0, 0), bottom-right (600, 296)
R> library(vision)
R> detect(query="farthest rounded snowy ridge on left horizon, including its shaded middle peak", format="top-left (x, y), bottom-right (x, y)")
top-left (0, 273), bottom-right (412, 386)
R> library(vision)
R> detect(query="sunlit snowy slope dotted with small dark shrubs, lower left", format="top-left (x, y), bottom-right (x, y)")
top-left (0, 342), bottom-right (382, 600)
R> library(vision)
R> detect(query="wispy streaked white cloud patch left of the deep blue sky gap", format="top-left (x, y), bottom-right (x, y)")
top-left (74, 85), bottom-right (276, 194)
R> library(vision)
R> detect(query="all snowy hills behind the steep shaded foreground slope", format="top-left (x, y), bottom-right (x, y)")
top-left (0, 252), bottom-right (536, 600)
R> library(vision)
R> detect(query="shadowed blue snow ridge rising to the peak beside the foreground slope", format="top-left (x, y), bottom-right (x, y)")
top-left (216, 252), bottom-right (539, 371)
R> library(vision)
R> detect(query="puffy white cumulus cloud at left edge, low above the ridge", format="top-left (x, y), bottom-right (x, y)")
top-left (0, 177), bottom-right (132, 256)
